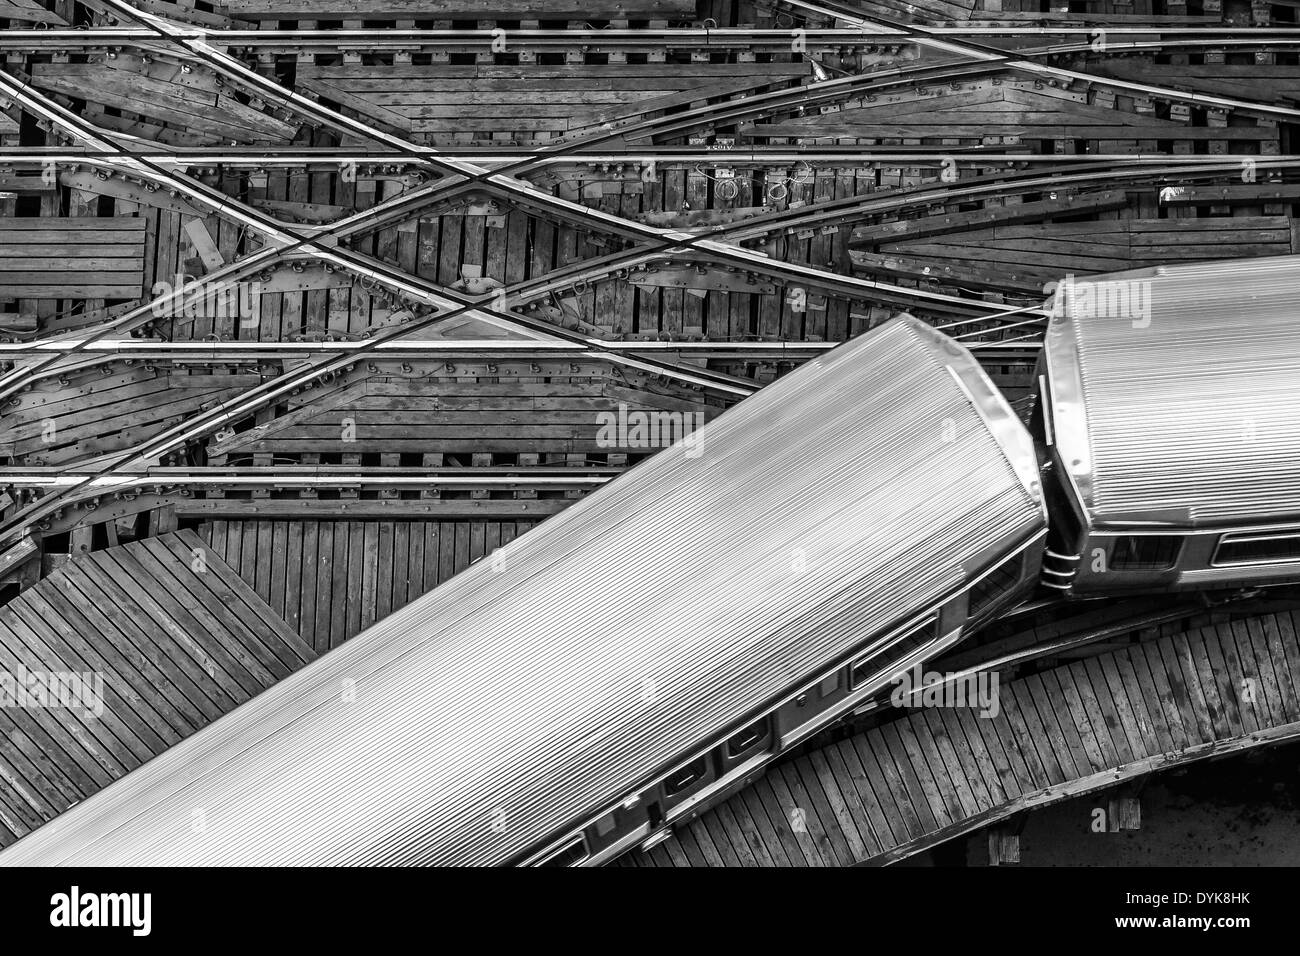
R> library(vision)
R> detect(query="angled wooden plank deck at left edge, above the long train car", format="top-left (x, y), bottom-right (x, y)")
top-left (0, 531), bottom-right (316, 847)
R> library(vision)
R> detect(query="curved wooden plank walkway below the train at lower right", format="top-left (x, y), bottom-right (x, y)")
top-left (619, 611), bottom-right (1300, 866)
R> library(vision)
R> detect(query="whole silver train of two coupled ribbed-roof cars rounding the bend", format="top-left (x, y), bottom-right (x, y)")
top-left (0, 254), bottom-right (1300, 865)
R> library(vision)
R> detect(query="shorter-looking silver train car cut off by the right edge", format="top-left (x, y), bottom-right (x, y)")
top-left (1034, 256), bottom-right (1300, 594)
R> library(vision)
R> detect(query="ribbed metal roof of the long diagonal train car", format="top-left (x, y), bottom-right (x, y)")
top-left (0, 316), bottom-right (1044, 865)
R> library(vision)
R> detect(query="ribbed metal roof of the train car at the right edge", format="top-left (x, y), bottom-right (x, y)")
top-left (1047, 256), bottom-right (1300, 527)
